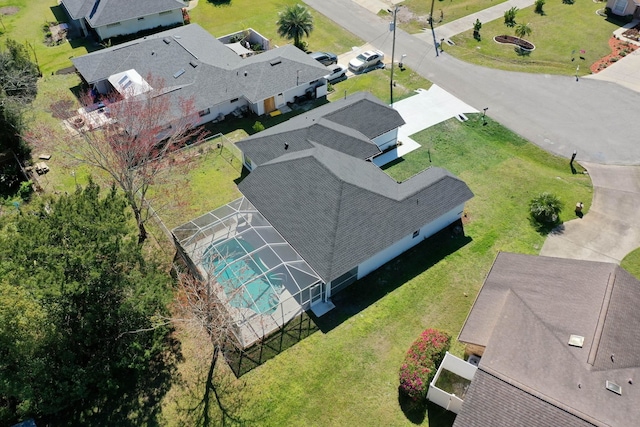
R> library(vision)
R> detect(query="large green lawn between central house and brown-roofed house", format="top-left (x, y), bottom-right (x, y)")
top-left (165, 115), bottom-right (592, 426)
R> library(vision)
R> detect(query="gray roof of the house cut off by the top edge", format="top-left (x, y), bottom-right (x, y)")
top-left (62, 0), bottom-right (187, 28)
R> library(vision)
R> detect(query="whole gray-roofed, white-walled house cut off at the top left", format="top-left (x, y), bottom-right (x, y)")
top-left (61, 0), bottom-right (187, 40)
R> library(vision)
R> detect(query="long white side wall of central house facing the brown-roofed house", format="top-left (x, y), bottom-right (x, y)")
top-left (358, 203), bottom-right (464, 279)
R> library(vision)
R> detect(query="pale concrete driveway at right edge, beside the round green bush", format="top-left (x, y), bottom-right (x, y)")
top-left (540, 163), bottom-right (640, 264)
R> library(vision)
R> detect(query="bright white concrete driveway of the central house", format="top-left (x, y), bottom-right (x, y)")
top-left (373, 85), bottom-right (479, 166)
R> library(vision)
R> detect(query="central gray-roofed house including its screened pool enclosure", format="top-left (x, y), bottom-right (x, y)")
top-left (173, 94), bottom-right (473, 344)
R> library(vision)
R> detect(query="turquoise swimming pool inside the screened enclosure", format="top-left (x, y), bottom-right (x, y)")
top-left (203, 239), bottom-right (283, 314)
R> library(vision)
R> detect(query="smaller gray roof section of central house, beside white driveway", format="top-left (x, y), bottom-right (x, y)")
top-left (236, 92), bottom-right (405, 165)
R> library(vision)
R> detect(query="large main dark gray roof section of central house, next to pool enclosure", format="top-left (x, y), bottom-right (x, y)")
top-left (238, 142), bottom-right (473, 282)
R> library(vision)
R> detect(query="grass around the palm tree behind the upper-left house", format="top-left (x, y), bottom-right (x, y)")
top-left (189, 0), bottom-right (364, 54)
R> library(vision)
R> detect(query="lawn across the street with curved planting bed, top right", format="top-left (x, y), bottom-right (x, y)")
top-left (447, 1), bottom-right (621, 75)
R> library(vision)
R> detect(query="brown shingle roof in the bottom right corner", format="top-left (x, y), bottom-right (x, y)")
top-left (455, 253), bottom-right (640, 427)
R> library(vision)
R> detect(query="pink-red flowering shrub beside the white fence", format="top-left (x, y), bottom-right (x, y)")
top-left (400, 329), bottom-right (451, 401)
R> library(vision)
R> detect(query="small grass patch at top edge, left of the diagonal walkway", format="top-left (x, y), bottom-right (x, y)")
top-left (378, 0), bottom-right (506, 34)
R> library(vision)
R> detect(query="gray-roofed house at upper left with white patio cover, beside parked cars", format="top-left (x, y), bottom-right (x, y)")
top-left (72, 24), bottom-right (327, 124)
